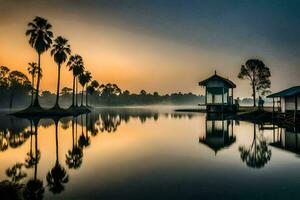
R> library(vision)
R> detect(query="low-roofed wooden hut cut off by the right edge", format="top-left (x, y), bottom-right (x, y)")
top-left (267, 86), bottom-right (300, 122)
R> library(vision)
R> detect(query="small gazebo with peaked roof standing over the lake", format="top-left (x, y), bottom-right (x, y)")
top-left (199, 71), bottom-right (237, 112)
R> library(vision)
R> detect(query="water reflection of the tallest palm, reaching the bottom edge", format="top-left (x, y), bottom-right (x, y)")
top-left (23, 120), bottom-right (45, 200)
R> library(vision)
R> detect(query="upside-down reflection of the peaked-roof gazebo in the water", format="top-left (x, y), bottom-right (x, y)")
top-left (199, 120), bottom-right (236, 154)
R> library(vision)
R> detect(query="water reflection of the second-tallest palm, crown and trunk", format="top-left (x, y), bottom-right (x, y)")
top-left (46, 120), bottom-right (69, 194)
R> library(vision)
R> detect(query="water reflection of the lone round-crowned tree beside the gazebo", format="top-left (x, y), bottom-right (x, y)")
top-left (239, 124), bottom-right (272, 168)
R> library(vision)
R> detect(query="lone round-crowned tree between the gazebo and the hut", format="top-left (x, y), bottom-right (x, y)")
top-left (238, 59), bottom-right (271, 107)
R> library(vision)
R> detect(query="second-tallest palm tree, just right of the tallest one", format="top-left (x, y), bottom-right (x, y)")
top-left (51, 36), bottom-right (71, 108)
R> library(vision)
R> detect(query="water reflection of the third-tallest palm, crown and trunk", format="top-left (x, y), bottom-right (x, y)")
top-left (66, 119), bottom-right (83, 169)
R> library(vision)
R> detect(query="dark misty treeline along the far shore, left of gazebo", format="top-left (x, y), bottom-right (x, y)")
top-left (0, 67), bottom-right (204, 108)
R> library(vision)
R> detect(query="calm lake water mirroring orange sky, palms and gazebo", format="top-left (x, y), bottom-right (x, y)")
top-left (0, 108), bottom-right (300, 200)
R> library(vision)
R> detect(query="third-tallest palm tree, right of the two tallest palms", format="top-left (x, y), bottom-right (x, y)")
top-left (67, 54), bottom-right (84, 107)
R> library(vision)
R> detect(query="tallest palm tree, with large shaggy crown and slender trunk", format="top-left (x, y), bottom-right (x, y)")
top-left (25, 17), bottom-right (53, 107)
